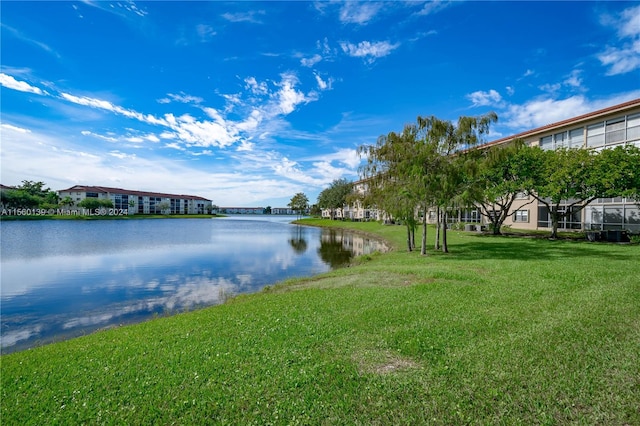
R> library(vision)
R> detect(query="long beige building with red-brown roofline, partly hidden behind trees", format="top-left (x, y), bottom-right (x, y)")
top-left (322, 99), bottom-right (640, 233)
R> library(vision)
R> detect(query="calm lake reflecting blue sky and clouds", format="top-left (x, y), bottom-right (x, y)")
top-left (0, 216), bottom-right (385, 354)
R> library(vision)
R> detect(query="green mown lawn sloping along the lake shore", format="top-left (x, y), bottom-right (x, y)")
top-left (0, 220), bottom-right (640, 425)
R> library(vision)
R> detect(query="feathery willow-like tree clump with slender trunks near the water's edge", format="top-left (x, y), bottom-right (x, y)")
top-left (359, 113), bottom-right (497, 254)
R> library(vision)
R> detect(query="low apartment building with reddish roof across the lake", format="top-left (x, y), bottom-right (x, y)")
top-left (58, 185), bottom-right (212, 214)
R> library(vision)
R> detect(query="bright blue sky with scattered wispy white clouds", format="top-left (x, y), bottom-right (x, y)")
top-left (0, 1), bottom-right (640, 207)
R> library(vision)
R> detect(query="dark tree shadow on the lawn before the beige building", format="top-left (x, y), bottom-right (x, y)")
top-left (438, 235), bottom-right (640, 261)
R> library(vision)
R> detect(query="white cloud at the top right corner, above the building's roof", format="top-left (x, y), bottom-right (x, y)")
top-left (597, 6), bottom-right (640, 76)
